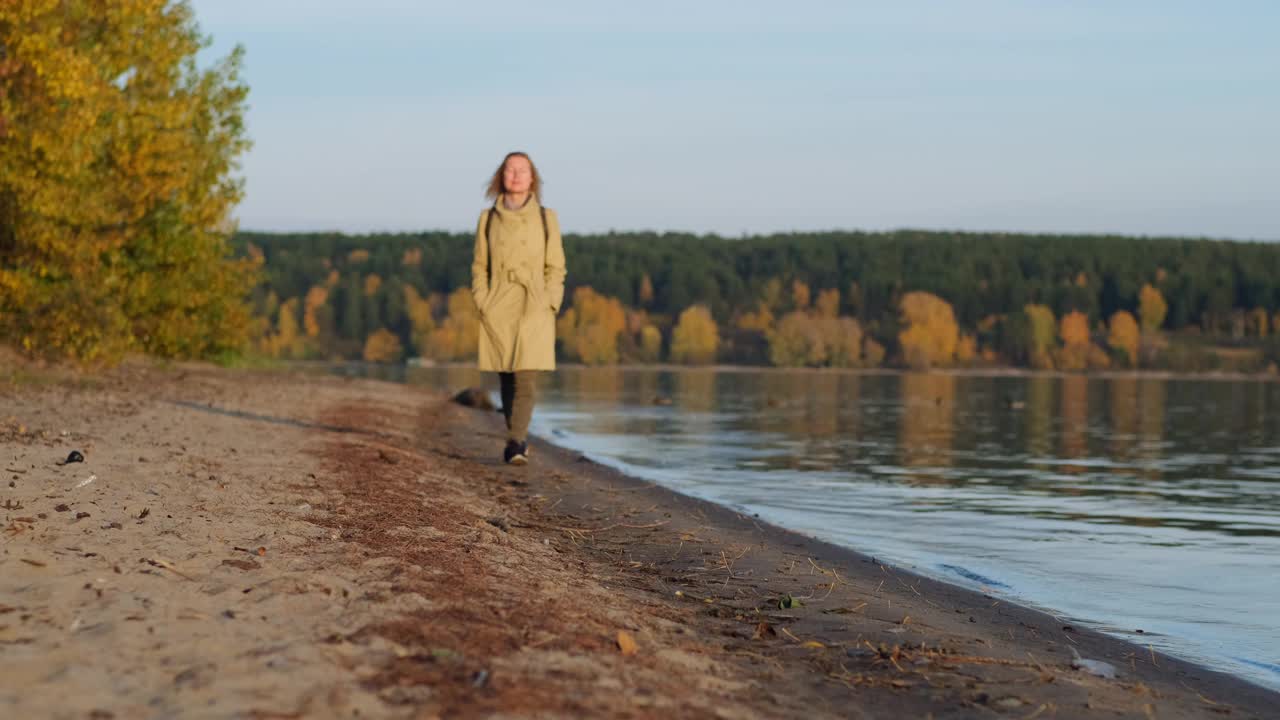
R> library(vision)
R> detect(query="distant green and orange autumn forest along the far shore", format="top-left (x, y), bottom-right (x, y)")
top-left (234, 231), bottom-right (1280, 370)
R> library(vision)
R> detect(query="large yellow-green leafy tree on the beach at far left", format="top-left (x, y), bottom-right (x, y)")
top-left (0, 0), bottom-right (257, 363)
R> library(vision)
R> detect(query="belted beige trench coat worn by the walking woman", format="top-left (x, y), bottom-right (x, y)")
top-left (471, 196), bottom-right (564, 373)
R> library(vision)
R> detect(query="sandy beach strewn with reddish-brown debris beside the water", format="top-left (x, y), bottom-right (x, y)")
top-left (0, 356), bottom-right (1280, 719)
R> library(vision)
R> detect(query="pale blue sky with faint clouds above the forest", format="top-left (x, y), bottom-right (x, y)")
top-left (193, 0), bottom-right (1280, 240)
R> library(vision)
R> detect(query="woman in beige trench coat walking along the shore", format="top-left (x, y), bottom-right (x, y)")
top-left (471, 152), bottom-right (564, 465)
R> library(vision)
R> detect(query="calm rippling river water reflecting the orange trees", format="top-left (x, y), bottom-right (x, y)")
top-left (360, 368), bottom-right (1280, 689)
